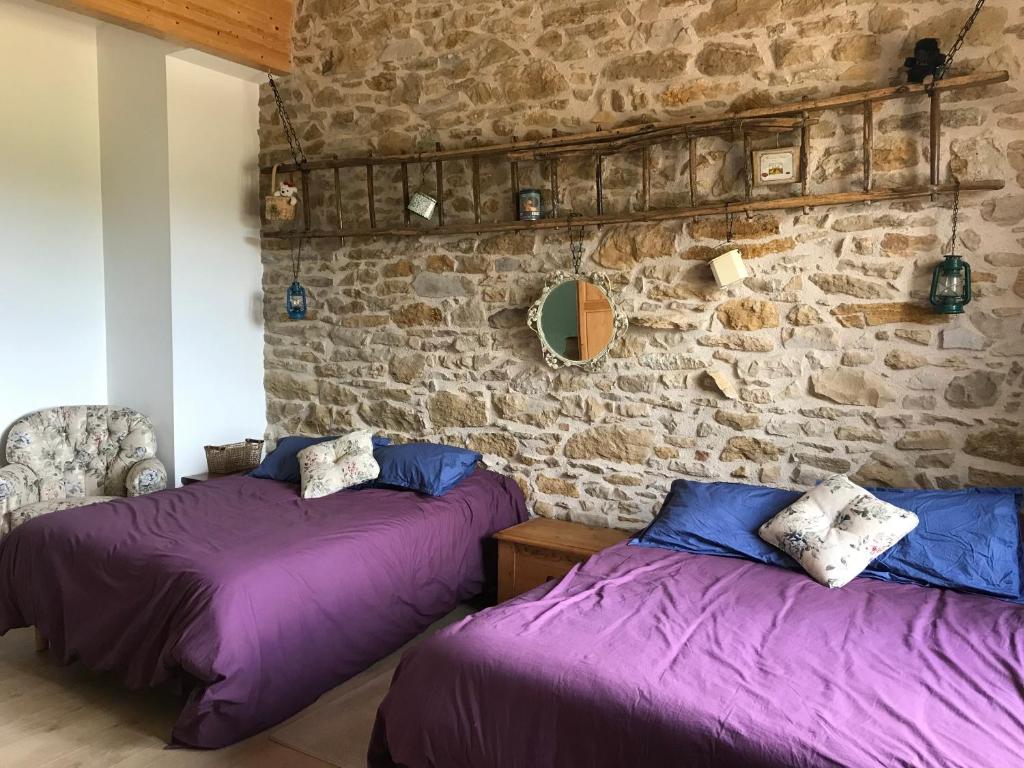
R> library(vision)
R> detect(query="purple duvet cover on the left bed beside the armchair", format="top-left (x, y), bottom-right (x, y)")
top-left (0, 470), bottom-right (526, 748)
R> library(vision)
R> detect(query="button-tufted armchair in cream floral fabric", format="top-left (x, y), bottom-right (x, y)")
top-left (0, 406), bottom-right (167, 537)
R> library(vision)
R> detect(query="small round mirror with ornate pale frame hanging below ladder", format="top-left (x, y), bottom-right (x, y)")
top-left (528, 272), bottom-right (628, 369)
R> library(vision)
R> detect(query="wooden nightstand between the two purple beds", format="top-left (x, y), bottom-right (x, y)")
top-left (495, 517), bottom-right (632, 602)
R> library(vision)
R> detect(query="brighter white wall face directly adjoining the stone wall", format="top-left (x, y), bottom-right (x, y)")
top-left (167, 53), bottom-right (266, 475)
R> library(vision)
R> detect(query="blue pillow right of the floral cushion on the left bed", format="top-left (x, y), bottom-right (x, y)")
top-left (373, 442), bottom-right (482, 496)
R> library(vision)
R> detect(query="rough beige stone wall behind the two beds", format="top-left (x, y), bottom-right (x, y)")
top-left (261, 0), bottom-right (1024, 525)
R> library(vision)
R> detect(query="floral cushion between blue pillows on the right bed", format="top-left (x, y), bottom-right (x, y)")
top-left (758, 475), bottom-right (918, 588)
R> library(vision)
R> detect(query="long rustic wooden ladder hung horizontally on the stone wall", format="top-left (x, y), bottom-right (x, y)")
top-left (260, 71), bottom-right (1010, 240)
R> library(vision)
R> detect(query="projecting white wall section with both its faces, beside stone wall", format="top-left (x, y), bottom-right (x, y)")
top-left (97, 33), bottom-right (266, 487)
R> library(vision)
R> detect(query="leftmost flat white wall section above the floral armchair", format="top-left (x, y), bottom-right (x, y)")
top-left (0, 0), bottom-right (108, 434)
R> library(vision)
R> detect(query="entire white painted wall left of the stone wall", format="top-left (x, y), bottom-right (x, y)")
top-left (0, 7), bottom-right (265, 487)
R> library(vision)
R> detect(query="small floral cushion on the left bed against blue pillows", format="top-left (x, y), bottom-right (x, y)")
top-left (298, 429), bottom-right (380, 499)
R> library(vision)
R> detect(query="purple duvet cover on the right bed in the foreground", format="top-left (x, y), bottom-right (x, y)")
top-left (370, 545), bottom-right (1024, 768)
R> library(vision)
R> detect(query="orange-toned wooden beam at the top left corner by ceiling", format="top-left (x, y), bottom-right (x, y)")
top-left (47, 0), bottom-right (293, 75)
